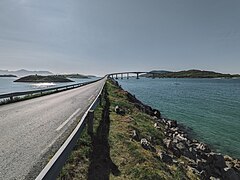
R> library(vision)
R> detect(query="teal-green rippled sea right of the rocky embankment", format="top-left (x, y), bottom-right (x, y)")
top-left (118, 78), bottom-right (240, 158)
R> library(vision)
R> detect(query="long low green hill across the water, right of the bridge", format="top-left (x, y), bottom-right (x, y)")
top-left (144, 69), bottom-right (240, 78)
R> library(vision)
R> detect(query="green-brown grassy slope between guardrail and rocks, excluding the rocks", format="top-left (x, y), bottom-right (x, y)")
top-left (59, 81), bottom-right (198, 180)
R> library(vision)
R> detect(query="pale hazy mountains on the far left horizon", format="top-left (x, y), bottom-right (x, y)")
top-left (0, 69), bottom-right (53, 77)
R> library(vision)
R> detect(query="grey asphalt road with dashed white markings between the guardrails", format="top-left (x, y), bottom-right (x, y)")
top-left (0, 79), bottom-right (106, 180)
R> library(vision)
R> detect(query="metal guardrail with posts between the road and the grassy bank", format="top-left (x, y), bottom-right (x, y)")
top-left (35, 76), bottom-right (106, 180)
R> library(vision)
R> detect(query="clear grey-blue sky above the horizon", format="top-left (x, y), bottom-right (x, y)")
top-left (0, 0), bottom-right (240, 75)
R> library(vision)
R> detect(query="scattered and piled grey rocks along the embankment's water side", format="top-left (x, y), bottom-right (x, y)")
top-left (115, 81), bottom-right (240, 180)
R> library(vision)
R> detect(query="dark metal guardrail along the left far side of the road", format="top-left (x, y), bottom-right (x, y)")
top-left (0, 77), bottom-right (104, 103)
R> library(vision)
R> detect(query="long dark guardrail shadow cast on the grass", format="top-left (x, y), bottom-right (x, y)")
top-left (88, 91), bottom-right (120, 180)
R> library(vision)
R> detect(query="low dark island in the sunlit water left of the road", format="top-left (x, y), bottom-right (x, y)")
top-left (14, 75), bottom-right (74, 83)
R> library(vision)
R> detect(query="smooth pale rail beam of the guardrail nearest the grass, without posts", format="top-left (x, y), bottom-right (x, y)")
top-left (35, 78), bottom-right (105, 180)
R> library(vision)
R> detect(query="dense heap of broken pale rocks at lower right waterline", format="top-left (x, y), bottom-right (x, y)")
top-left (159, 118), bottom-right (240, 180)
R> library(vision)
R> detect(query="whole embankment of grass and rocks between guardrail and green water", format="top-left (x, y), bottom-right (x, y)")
top-left (58, 79), bottom-right (240, 180)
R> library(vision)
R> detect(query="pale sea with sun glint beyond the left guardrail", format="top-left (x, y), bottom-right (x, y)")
top-left (0, 77), bottom-right (98, 94)
